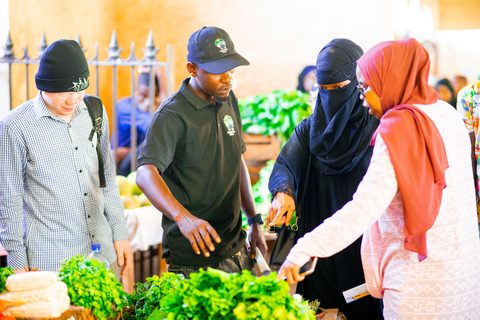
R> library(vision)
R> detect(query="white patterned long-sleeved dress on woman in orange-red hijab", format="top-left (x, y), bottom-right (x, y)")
top-left (288, 101), bottom-right (480, 320)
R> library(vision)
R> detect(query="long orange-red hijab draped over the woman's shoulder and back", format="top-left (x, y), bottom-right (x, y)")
top-left (358, 39), bottom-right (448, 261)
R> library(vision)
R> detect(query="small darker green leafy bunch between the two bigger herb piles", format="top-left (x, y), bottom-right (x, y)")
top-left (123, 272), bottom-right (184, 320)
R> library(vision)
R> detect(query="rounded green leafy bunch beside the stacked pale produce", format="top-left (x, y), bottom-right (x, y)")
top-left (58, 255), bottom-right (125, 320)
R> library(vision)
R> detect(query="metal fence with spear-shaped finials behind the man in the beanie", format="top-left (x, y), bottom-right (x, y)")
top-left (0, 31), bottom-right (175, 171)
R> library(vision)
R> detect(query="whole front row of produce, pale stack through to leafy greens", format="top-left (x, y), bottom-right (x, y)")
top-left (0, 264), bottom-right (316, 320)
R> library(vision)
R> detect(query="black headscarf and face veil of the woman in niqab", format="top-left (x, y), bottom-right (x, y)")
top-left (310, 39), bottom-right (378, 174)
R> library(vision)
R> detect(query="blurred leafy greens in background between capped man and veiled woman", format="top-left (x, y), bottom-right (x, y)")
top-left (238, 89), bottom-right (312, 144)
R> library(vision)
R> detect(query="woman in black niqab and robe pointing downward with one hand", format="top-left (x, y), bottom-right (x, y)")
top-left (267, 39), bottom-right (383, 320)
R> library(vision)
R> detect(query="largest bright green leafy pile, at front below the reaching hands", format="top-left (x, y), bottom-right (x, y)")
top-left (149, 268), bottom-right (315, 320)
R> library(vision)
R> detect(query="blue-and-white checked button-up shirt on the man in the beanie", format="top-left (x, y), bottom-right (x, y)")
top-left (0, 93), bottom-right (128, 271)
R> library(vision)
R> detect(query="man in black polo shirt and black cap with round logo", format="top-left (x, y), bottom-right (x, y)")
top-left (137, 27), bottom-right (266, 277)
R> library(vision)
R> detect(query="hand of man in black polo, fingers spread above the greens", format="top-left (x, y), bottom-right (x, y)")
top-left (175, 213), bottom-right (221, 258)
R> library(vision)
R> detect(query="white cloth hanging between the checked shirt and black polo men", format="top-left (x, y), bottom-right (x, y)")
top-left (125, 206), bottom-right (163, 252)
